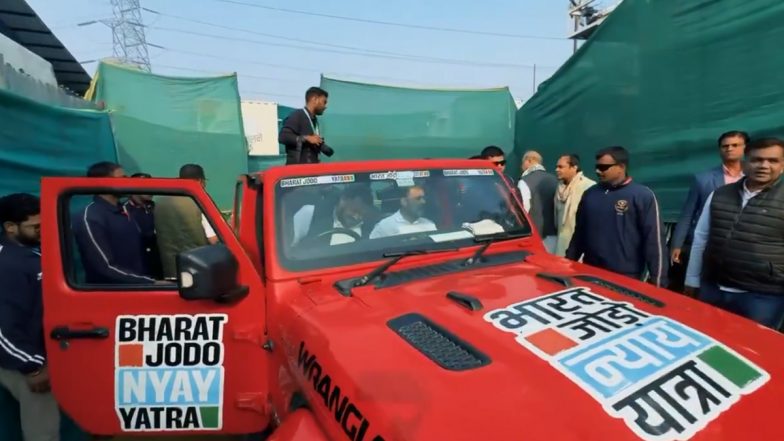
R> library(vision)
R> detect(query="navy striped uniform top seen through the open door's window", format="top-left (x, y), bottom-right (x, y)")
top-left (73, 196), bottom-right (155, 284)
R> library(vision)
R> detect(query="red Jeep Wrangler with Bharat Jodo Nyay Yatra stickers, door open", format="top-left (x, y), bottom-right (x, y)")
top-left (42, 160), bottom-right (784, 441)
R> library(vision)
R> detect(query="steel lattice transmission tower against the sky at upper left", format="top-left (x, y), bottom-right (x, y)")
top-left (106, 0), bottom-right (151, 72)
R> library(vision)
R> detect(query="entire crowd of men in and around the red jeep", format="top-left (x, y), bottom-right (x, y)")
top-left (0, 107), bottom-right (784, 440)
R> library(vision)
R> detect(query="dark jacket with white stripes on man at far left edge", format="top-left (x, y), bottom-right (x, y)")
top-left (0, 235), bottom-right (46, 374)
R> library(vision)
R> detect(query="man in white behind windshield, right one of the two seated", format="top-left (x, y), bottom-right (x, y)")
top-left (370, 185), bottom-right (437, 239)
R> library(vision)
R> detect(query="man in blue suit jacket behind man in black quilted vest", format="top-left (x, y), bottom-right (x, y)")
top-left (670, 130), bottom-right (749, 292)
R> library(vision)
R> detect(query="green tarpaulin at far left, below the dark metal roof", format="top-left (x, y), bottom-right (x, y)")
top-left (0, 90), bottom-right (117, 195)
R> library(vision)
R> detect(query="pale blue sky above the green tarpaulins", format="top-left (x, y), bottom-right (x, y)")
top-left (27, 0), bottom-right (572, 106)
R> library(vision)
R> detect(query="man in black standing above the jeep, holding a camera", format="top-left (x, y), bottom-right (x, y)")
top-left (279, 87), bottom-right (335, 165)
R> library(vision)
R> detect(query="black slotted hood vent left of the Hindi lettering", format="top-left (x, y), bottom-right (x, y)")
top-left (387, 313), bottom-right (490, 371)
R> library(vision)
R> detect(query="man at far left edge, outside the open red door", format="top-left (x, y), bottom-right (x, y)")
top-left (0, 193), bottom-right (60, 441)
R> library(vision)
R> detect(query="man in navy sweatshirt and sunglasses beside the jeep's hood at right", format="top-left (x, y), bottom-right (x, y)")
top-left (566, 147), bottom-right (667, 286)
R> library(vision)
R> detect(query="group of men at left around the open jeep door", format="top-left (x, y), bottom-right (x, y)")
top-left (0, 162), bottom-right (218, 441)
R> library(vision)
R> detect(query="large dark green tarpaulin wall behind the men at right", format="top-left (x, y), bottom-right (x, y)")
top-left (516, 0), bottom-right (784, 221)
